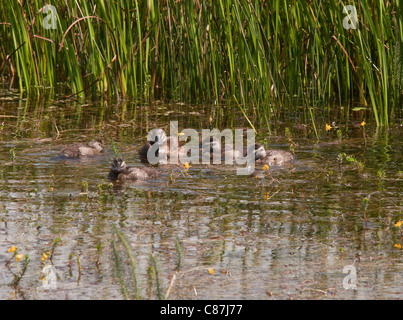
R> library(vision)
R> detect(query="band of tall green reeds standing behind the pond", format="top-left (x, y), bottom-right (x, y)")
top-left (0, 0), bottom-right (403, 125)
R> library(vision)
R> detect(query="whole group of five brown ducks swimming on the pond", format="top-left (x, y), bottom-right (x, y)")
top-left (61, 129), bottom-right (294, 182)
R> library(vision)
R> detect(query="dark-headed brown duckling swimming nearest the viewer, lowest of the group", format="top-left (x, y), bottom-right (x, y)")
top-left (108, 157), bottom-right (159, 182)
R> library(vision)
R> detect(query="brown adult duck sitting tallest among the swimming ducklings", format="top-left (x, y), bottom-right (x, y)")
top-left (138, 128), bottom-right (188, 164)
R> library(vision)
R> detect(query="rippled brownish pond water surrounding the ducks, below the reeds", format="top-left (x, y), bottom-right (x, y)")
top-left (0, 96), bottom-right (403, 299)
